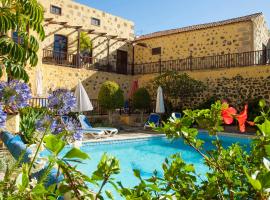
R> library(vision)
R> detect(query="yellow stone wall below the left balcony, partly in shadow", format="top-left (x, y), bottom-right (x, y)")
top-left (27, 64), bottom-right (132, 99)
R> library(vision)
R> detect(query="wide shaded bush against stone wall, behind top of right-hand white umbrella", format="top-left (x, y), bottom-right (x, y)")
top-left (150, 71), bottom-right (206, 99)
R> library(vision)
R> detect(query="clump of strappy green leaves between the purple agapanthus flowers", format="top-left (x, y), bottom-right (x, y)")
top-left (20, 107), bottom-right (48, 144)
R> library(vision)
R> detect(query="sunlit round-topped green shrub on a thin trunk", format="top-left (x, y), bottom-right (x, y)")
top-left (98, 81), bottom-right (124, 123)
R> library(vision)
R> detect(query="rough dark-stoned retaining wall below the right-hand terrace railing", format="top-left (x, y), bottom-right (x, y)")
top-left (136, 66), bottom-right (270, 108)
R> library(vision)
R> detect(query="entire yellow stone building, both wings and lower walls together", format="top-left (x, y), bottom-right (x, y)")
top-left (17, 0), bottom-right (270, 106)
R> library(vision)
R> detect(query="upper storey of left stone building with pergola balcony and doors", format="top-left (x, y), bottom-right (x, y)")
top-left (40, 0), bottom-right (134, 73)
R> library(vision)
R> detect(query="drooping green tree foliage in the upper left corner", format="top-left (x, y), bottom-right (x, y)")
top-left (0, 0), bottom-right (45, 81)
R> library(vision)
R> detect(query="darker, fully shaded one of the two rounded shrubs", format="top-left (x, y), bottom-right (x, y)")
top-left (132, 88), bottom-right (151, 110)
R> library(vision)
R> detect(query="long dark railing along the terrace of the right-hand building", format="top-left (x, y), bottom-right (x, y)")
top-left (134, 49), bottom-right (270, 74)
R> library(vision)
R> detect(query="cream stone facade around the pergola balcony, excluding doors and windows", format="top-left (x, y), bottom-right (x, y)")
top-left (40, 0), bottom-right (134, 70)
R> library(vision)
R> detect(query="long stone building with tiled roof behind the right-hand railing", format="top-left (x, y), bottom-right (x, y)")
top-left (135, 13), bottom-right (269, 64)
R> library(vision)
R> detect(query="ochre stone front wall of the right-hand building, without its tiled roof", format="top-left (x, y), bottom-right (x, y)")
top-left (135, 22), bottom-right (253, 63)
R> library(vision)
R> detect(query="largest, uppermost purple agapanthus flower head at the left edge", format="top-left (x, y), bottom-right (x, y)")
top-left (0, 80), bottom-right (31, 112)
